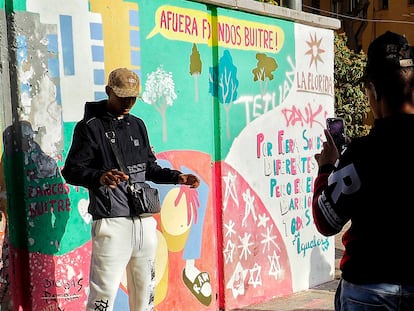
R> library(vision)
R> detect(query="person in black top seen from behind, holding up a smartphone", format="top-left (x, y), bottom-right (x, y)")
top-left (312, 31), bottom-right (414, 311)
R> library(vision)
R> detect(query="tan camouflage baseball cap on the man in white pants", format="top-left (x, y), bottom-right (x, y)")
top-left (108, 68), bottom-right (139, 97)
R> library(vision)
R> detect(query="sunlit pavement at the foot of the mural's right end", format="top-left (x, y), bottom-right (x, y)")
top-left (231, 226), bottom-right (348, 311)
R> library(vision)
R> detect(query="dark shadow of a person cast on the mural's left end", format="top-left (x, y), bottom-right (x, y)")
top-left (0, 121), bottom-right (70, 310)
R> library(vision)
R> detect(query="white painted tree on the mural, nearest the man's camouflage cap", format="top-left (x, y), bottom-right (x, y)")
top-left (142, 65), bottom-right (177, 141)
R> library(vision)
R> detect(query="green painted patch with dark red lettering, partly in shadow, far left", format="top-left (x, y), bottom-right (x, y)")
top-left (3, 124), bottom-right (90, 255)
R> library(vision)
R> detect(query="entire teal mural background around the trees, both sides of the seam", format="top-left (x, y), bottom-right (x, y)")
top-left (137, 1), bottom-right (295, 161)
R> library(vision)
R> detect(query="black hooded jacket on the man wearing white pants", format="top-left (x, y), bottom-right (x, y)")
top-left (62, 100), bottom-right (181, 220)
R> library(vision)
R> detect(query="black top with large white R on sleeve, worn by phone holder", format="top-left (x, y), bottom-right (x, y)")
top-left (313, 114), bottom-right (414, 285)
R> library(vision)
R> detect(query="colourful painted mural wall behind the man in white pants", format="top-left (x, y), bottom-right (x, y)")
top-left (0, 0), bottom-right (335, 311)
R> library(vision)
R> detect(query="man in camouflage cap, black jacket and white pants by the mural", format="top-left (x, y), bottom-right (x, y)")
top-left (62, 68), bottom-right (200, 311)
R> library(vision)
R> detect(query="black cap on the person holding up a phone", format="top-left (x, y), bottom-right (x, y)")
top-left (365, 31), bottom-right (414, 77)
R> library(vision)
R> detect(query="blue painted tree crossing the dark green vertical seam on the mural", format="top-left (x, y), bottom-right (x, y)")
top-left (209, 50), bottom-right (239, 138)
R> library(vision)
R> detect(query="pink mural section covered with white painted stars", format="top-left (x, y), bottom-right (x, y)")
top-left (216, 162), bottom-right (292, 309)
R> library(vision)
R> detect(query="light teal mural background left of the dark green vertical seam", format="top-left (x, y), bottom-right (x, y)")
top-left (139, 1), bottom-right (214, 154)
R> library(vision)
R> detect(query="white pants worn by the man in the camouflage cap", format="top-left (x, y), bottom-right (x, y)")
top-left (87, 217), bottom-right (158, 311)
